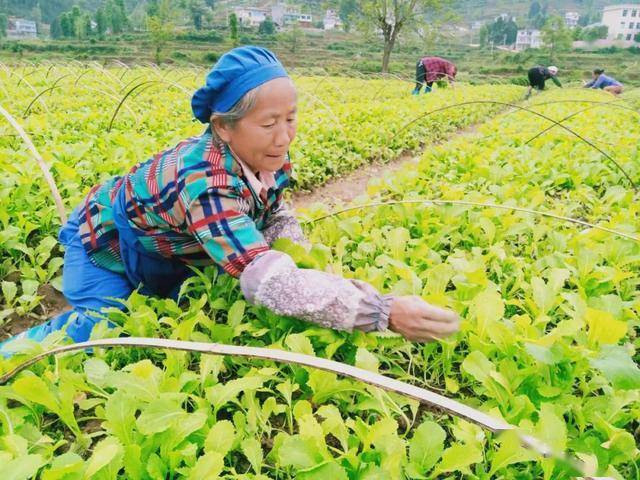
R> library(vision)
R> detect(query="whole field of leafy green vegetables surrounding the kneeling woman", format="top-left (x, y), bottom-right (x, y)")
top-left (0, 65), bottom-right (640, 480)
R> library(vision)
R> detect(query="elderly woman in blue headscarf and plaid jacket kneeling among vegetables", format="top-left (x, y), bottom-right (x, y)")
top-left (0, 46), bottom-right (459, 352)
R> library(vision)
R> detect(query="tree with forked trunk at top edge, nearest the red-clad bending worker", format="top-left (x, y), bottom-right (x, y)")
top-left (360, 0), bottom-right (439, 72)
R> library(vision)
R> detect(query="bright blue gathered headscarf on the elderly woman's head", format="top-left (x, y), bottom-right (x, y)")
top-left (191, 46), bottom-right (288, 123)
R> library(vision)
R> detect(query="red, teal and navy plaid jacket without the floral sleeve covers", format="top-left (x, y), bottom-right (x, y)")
top-left (79, 129), bottom-right (291, 277)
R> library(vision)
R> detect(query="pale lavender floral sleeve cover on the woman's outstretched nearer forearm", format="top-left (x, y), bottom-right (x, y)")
top-left (240, 250), bottom-right (393, 332)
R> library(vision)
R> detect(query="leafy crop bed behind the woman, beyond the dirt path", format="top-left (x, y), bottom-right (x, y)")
top-left (0, 65), bottom-right (522, 322)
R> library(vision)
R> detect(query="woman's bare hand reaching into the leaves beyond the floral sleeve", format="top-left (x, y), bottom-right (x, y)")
top-left (389, 296), bottom-right (460, 342)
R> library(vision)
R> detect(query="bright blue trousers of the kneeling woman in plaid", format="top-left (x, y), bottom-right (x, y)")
top-left (0, 209), bottom-right (134, 354)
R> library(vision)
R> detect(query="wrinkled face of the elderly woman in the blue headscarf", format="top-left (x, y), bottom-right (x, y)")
top-left (216, 78), bottom-right (297, 172)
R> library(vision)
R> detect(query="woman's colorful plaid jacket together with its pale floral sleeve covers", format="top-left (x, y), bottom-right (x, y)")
top-left (78, 130), bottom-right (393, 331)
